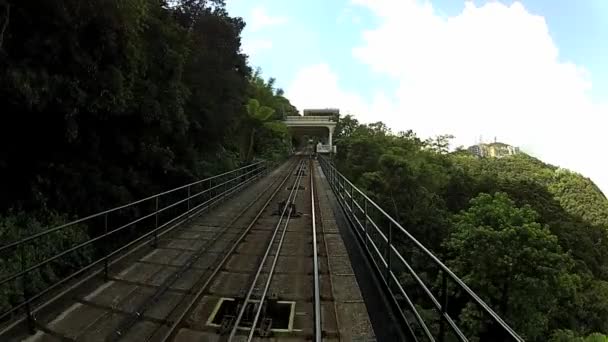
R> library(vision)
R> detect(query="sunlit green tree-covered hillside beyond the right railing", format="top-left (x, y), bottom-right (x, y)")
top-left (335, 116), bottom-right (608, 341)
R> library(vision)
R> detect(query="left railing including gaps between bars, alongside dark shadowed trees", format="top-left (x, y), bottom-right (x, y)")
top-left (0, 162), bottom-right (268, 331)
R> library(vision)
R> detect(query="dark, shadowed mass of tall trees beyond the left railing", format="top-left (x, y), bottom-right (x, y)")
top-left (0, 0), bottom-right (297, 318)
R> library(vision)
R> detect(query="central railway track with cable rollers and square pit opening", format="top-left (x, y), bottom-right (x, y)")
top-left (162, 158), bottom-right (335, 341)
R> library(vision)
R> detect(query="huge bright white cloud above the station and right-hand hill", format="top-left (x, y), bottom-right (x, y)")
top-left (290, 0), bottom-right (608, 194)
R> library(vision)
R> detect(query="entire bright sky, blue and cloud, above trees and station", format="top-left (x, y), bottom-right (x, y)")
top-left (227, 0), bottom-right (608, 194)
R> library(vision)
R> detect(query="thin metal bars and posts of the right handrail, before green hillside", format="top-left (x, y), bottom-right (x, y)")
top-left (319, 156), bottom-right (523, 341)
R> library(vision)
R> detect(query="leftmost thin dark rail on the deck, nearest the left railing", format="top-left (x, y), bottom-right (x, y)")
top-left (106, 160), bottom-right (302, 342)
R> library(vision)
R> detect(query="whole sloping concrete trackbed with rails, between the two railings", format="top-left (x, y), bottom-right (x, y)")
top-left (20, 156), bottom-right (376, 342)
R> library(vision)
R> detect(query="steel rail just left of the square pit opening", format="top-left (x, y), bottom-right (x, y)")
top-left (160, 158), bottom-right (298, 342)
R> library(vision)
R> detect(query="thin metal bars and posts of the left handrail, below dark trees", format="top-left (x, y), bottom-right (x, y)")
top-left (0, 161), bottom-right (269, 330)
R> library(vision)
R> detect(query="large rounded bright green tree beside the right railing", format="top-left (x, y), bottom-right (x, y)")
top-left (445, 193), bottom-right (578, 341)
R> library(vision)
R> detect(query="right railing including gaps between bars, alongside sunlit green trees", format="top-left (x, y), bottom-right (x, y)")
top-left (319, 157), bottom-right (523, 341)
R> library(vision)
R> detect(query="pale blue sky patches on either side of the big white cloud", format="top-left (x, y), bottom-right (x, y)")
top-left (227, 0), bottom-right (608, 99)
